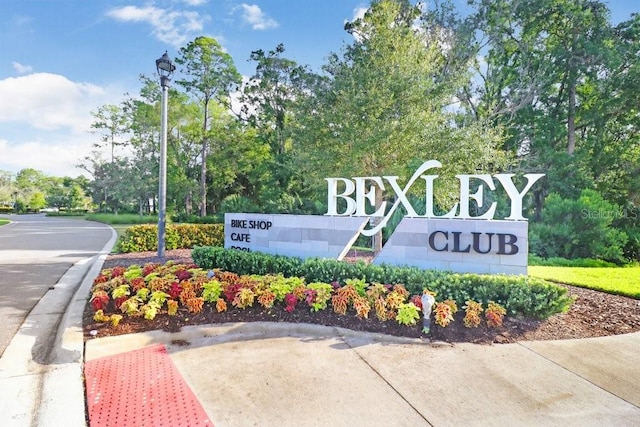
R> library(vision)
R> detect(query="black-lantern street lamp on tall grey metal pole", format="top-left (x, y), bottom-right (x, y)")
top-left (156, 51), bottom-right (176, 258)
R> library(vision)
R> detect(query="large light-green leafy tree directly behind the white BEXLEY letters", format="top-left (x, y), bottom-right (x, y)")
top-left (294, 0), bottom-right (501, 248)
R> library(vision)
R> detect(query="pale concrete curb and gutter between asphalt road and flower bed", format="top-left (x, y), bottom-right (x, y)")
top-left (0, 228), bottom-right (117, 427)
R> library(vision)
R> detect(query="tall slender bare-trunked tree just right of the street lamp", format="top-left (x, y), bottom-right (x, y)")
top-left (176, 36), bottom-right (240, 216)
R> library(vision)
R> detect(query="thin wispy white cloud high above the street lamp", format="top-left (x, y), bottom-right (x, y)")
top-left (107, 5), bottom-right (209, 47)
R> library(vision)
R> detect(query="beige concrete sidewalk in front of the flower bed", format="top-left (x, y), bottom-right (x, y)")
top-left (85, 323), bottom-right (640, 426)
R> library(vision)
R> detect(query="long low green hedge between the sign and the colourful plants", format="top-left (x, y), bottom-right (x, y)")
top-left (191, 246), bottom-right (573, 319)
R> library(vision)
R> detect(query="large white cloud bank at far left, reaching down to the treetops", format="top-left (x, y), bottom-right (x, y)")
top-left (0, 73), bottom-right (124, 177)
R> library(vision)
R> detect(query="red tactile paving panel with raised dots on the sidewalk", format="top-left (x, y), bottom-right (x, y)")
top-left (84, 344), bottom-right (213, 427)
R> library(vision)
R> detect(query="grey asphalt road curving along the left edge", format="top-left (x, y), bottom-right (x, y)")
top-left (0, 214), bottom-right (112, 356)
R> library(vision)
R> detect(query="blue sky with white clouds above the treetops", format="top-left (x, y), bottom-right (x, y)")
top-left (0, 0), bottom-right (640, 177)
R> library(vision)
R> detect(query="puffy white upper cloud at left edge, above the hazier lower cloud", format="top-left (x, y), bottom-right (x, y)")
top-left (0, 73), bottom-right (107, 133)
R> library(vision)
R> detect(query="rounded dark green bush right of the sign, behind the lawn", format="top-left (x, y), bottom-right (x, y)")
top-left (530, 189), bottom-right (627, 263)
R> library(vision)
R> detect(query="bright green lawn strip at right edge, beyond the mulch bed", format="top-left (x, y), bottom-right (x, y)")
top-left (529, 266), bottom-right (640, 299)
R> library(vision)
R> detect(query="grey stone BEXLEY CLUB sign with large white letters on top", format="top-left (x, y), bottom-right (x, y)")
top-left (225, 160), bottom-right (544, 274)
